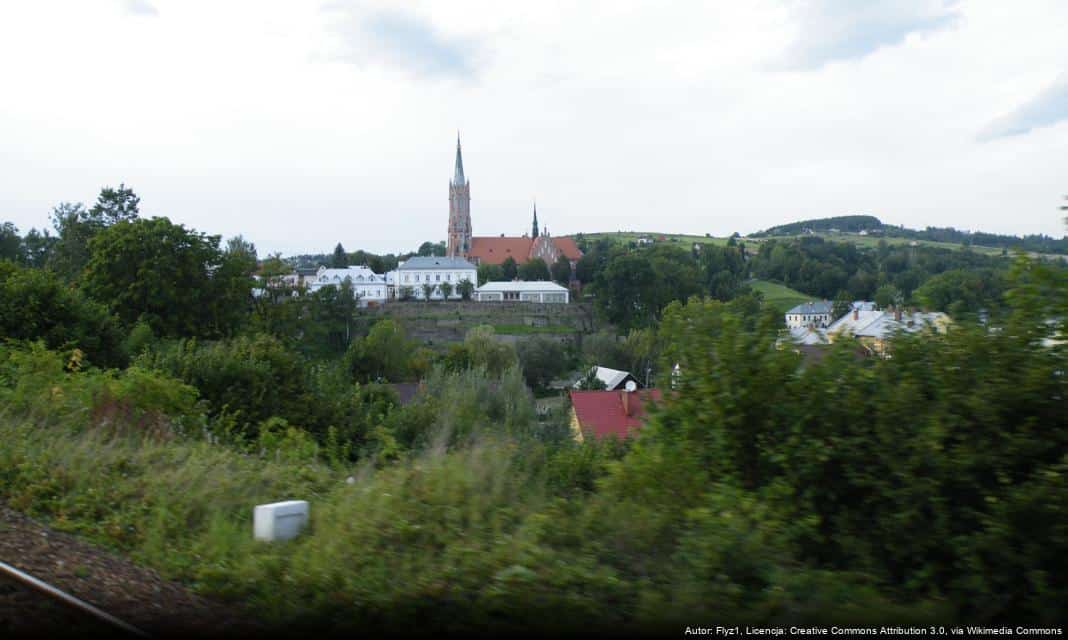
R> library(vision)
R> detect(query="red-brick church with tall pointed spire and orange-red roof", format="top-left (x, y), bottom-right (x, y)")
top-left (445, 136), bottom-right (582, 274)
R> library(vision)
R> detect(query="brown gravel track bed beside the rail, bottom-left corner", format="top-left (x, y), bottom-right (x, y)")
top-left (0, 505), bottom-right (263, 638)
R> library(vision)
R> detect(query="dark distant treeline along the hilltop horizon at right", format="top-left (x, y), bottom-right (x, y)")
top-left (750, 216), bottom-right (1068, 253)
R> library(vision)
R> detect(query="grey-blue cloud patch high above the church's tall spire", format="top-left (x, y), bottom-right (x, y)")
top-left (326, 3), bottom-right (475, 77)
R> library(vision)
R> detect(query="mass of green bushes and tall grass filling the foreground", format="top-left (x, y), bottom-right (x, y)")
top-left (0, 183), bottom-right (1068, 634)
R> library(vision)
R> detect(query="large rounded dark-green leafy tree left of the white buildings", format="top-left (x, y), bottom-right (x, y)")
top-left (82, 218), bottom-right (246, 337)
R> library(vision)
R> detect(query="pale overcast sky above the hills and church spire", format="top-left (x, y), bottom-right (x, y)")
top-left (0, 0), bottom-right (1068, 255)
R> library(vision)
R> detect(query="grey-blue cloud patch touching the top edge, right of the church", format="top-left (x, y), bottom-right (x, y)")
top-left (773, 0), bottom-right (960, 69)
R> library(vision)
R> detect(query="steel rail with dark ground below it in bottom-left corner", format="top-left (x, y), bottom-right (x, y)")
top-left (0, 562), bottom-right (148, 638)
